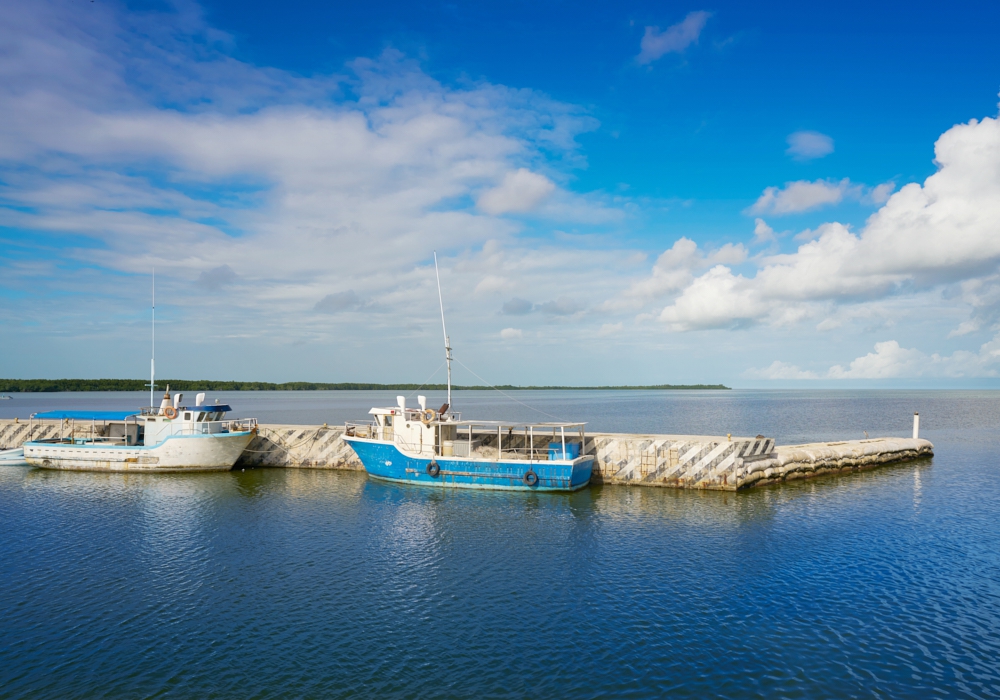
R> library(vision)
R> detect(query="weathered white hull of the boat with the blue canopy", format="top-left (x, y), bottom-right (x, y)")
top-left (24, 430), bottom-right (256, 472)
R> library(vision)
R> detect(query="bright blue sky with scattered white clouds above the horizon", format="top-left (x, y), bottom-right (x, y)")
top-left (0, 0), bottom-right (1000, 387)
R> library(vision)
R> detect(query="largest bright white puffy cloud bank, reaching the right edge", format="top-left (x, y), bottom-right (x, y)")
top-left (660, 113), bottom-right (1000, 330)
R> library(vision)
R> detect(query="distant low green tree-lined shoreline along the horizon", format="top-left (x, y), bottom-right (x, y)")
top-left (0, 379), bottom-right (731, 393)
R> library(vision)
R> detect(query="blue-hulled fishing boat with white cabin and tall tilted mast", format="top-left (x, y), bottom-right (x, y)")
top-left (344, 254), bottom-right (594, 491)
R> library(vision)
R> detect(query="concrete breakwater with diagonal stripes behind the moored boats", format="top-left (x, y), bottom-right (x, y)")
top-left (0, 421), bottom-right (934, 491)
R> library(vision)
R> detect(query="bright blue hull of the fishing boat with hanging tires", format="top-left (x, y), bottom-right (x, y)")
top-left (344, 437), bottom-right (594, 491)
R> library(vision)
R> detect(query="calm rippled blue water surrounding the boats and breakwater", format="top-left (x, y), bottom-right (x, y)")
top-left (0, 392), bottom-right (1000, 698)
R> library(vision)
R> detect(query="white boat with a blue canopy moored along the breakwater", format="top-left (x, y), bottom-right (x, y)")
top-left (23, 391), bottom-right (257, 472)
